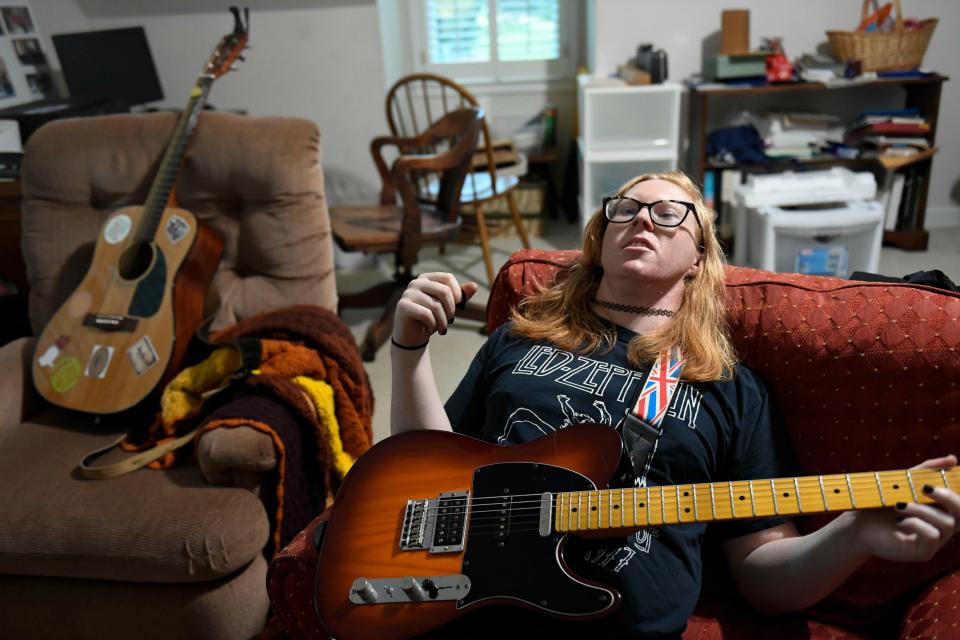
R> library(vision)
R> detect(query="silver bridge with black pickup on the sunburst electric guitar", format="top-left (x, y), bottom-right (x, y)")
top-left (400, 491), bottom-right (470, 553)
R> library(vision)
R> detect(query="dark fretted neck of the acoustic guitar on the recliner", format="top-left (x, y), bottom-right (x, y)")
top-left (136, 74), bottom-right (213, 242)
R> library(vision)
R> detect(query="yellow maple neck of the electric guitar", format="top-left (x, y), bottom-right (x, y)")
top-left (553, 467), bottom-right (960, 535)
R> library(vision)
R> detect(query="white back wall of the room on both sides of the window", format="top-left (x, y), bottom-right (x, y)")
top-left (22, 0), bottom-right (960, 223)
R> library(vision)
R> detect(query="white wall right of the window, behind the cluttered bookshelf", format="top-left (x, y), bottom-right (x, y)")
top-left (587, 0), bottom-right (960, 226)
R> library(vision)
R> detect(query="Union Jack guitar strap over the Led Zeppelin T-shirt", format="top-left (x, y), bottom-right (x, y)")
top-left (620, 347), bottom-right (684, 478)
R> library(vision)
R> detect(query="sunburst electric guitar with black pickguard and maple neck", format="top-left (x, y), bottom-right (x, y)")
top-left (314, 425), bottom-right (960, 640)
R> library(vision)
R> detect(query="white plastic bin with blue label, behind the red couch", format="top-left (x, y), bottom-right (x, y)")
top-left (749, 201), bottom-right (884, 278)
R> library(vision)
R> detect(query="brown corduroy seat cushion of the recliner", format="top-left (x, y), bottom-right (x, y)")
top-left (0, 408), bottom-right (270, 582)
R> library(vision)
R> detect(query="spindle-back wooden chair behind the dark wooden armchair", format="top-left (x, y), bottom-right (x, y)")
top-left (386, 73), bottom-right (530, 286)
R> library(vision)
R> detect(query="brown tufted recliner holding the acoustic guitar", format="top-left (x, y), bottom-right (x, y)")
top-left (0, 113), bottom-right (337, 640)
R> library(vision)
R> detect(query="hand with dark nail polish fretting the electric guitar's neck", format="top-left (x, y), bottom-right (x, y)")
top-left (854, 455), bottom-right (960, 562)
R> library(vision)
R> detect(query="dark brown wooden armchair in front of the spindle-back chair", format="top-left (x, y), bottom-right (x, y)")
top-left (330, 107), bottom-right (484, 362)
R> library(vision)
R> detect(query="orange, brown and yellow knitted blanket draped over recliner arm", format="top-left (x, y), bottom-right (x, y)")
top-left (125, 305), bottom-right (373, 551)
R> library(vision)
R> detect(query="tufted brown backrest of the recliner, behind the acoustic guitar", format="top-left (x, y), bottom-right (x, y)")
top-left (22, 112), bottom-right (337, 332)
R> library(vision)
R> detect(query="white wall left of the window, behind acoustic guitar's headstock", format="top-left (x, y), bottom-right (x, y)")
top-left (33, 0), bottom-right (386, 204)
